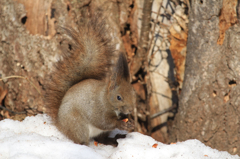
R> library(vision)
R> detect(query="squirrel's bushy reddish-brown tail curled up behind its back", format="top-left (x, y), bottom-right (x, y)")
top-left (45, 17), bottom-right (114, 119)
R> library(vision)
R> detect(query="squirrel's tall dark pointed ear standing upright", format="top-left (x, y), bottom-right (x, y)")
top-left (109, 53), bottom-right (130, 89)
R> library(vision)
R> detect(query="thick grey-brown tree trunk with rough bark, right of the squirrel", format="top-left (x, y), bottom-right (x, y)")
top-left (170, 0), bottom-right (240, 155)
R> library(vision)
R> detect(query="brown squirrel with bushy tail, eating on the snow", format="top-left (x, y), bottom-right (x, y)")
top-left (45, 17), bottom-right (135, 145)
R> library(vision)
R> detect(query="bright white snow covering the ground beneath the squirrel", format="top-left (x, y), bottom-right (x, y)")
top-left (0, 115), bottom-right (239, 159)
